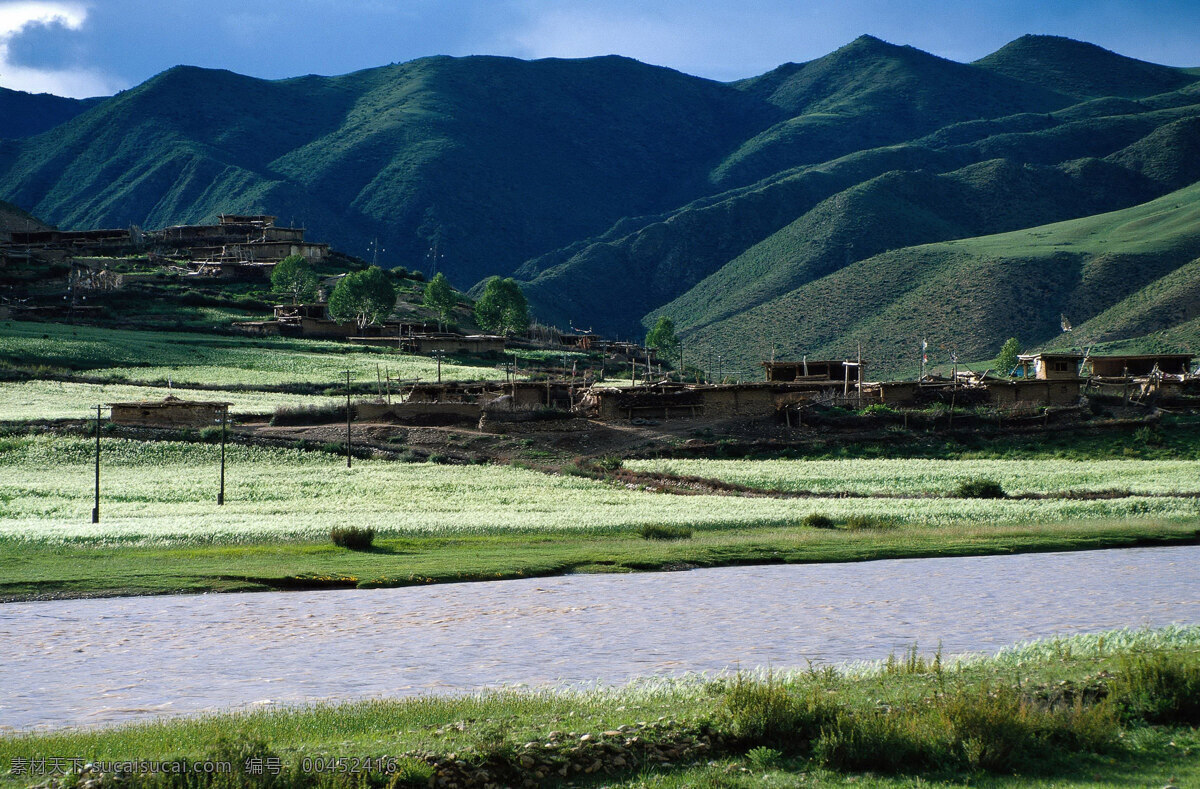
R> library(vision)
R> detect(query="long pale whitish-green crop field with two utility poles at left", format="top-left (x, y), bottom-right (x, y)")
top-left (0, 434), bottom-right (1200, 544)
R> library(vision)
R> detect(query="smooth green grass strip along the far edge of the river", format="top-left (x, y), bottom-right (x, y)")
top-left (9, 520), bottom-right (1200, 600)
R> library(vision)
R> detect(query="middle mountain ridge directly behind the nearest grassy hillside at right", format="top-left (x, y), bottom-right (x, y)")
top-left (518, 98), bottom-right (1200, 333)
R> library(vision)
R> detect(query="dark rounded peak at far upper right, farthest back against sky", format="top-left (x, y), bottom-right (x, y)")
top-left (974, 36), bottom-right (1196, 98)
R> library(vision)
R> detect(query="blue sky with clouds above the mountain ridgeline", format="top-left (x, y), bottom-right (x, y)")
top-left (0, 0), bottom-right (1200, 97)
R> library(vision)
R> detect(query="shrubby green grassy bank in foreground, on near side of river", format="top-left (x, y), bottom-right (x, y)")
top-left (0, 627), bottom-right (1200, 789)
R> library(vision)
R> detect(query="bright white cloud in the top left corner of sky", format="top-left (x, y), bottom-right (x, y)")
top-left (0, 0), bottom-right (121, 98)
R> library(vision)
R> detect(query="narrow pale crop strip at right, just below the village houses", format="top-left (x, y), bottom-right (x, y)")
top-left (624, 450), bottom-right (1200, 496)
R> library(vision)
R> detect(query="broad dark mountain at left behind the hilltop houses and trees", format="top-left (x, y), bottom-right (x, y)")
top-left (0, 58), bottom-right (775, 283)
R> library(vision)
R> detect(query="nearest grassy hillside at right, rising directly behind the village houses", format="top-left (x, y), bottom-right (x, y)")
top-left (676, 178), bottom-right (1200, 373)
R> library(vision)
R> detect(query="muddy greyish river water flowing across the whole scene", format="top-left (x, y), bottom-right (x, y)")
top-left (0, 547), bottom-right (1200, 729)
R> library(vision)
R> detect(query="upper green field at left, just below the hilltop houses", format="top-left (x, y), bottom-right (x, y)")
top-left (0, 321), bottom-right (504, 387)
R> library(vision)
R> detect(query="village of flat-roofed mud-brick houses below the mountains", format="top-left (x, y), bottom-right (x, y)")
top-left (7, 215), bottom-right (1200, 441)
